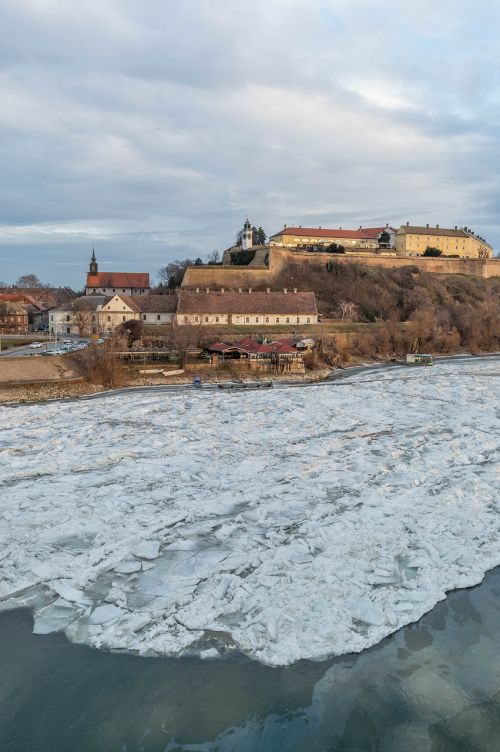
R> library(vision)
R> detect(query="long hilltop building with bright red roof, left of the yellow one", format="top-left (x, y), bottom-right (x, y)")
top-left (269, 224), bottom-right (396, 250)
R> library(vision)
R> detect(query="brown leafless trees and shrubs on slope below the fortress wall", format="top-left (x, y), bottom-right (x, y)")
top-left (275, 261), bottom-right (500, 356)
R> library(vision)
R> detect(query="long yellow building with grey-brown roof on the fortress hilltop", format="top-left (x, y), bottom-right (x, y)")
top-left (396, 223), bottom-right (493, 258)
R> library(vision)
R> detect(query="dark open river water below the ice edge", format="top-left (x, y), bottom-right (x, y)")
top-left (0, 569), bottom-right (500, 752)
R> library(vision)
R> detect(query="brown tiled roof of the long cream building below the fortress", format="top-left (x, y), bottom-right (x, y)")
top-left (177, 290), bottom-right (318, 316)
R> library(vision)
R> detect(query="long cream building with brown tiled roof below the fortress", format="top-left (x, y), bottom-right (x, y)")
top-left (176, 288), bottom-right (318, 326)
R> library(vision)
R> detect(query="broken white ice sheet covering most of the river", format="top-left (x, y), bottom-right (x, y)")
top-left (0, 359), bottom-right (500, 665)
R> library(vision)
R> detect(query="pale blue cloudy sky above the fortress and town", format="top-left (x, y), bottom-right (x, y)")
top-left (0, 0), bottom-right (500, 289)
